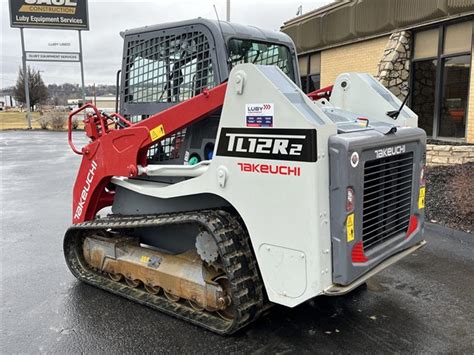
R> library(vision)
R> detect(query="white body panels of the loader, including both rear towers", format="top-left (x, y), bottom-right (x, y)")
top-left (112, 64), bottom-right (426, 307)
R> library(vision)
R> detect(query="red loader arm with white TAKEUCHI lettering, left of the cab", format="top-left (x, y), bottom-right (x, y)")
top-left (69, 83), bottom-right (227, 224)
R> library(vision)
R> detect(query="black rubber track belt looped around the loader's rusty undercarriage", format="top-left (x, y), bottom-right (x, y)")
top-left (63, 210), bottom-right (264, 334)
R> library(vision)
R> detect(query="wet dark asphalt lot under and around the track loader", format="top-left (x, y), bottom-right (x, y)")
top-left (0, 131), bottom-right (474, 354)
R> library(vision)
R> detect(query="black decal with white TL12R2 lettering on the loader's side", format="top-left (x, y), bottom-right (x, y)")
top-left (217, 128), bottom-right (317, 162)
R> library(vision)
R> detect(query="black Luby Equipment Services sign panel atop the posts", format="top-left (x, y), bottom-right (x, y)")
top-left (9, 0), bottom-right (89, 30)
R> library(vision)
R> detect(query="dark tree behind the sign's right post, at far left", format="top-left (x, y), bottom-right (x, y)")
top-left (13, 66), bottom-right (48, 111)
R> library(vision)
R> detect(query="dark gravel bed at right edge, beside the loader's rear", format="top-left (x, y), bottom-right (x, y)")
top-left (426, 163), bottom-right (474, 234)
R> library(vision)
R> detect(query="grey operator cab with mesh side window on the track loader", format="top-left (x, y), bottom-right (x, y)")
top-left (118, 18), bottom-right (301, 171)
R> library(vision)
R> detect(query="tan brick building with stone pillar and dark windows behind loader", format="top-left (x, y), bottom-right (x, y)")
top-left (282, 0), bottom-right (474, 143)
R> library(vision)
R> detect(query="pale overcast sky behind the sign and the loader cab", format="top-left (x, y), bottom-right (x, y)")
top-left (0, 0), bottom-right (332, 88)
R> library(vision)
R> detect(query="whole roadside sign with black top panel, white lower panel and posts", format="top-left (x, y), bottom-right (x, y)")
top-left (9, 0), bottom-right (89, 129)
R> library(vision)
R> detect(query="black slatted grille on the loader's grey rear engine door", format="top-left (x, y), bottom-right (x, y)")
top-left (362, 152), bottom-right (413, 251)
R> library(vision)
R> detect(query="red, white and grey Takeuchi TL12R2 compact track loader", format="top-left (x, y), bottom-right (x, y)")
top-left (64, 19), bottom-right (425, 334)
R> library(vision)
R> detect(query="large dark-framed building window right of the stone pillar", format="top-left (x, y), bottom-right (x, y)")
top-left (411, 21), bottom-right (473, 138)
